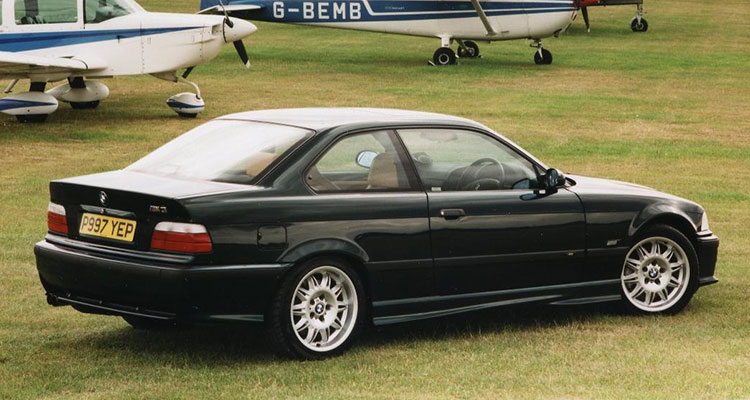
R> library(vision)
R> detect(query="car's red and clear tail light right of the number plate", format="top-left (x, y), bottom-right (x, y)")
top-left (151, 222), bottom-right (213, 254)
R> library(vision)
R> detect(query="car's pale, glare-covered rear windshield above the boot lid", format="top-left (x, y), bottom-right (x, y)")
top-left (126, 120), bottom-right (313, 183)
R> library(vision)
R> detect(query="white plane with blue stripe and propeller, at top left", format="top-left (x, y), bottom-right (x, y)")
top-left (0, 0), bottom-right (256, 122)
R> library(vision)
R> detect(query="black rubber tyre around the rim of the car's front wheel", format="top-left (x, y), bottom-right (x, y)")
top-left (620, 224), bottom-right (700, 315)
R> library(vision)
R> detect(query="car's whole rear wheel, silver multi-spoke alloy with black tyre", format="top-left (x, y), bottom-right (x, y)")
top-left (268, 257), bottom-right (367, 360)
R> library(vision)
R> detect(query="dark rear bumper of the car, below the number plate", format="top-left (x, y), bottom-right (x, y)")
top-left (34, 238), bottom-right (291, 322)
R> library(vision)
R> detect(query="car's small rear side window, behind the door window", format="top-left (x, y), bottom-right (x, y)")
top-left (305, 131), bottom-right (418, 193)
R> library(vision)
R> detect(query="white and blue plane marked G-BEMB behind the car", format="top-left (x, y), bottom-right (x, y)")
top-left (200, 0), bottom-right (581, 65)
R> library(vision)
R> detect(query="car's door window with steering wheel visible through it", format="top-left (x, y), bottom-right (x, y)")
top-left (398, 129), bottom-right (539, 192)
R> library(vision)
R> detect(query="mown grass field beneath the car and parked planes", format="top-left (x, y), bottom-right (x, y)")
top-left (0, 0), bottom-right (750, 399)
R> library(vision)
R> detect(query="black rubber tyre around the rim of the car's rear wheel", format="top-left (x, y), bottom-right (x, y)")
top-left (266, 256), bottom-right (369, 360)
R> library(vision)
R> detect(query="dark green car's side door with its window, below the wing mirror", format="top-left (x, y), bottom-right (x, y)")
top-left (398, 129), bottom-right (585, 296)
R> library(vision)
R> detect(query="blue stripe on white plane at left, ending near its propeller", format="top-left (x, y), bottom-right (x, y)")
top-left (0, 26), bottom-right (200, 52)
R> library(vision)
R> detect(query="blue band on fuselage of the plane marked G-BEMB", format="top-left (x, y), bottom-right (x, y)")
top-left (201, 0), bottom-right (574, 23)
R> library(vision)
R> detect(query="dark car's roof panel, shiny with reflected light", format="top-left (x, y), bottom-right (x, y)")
top-left (218, 107), bottom-right (484, 131)
